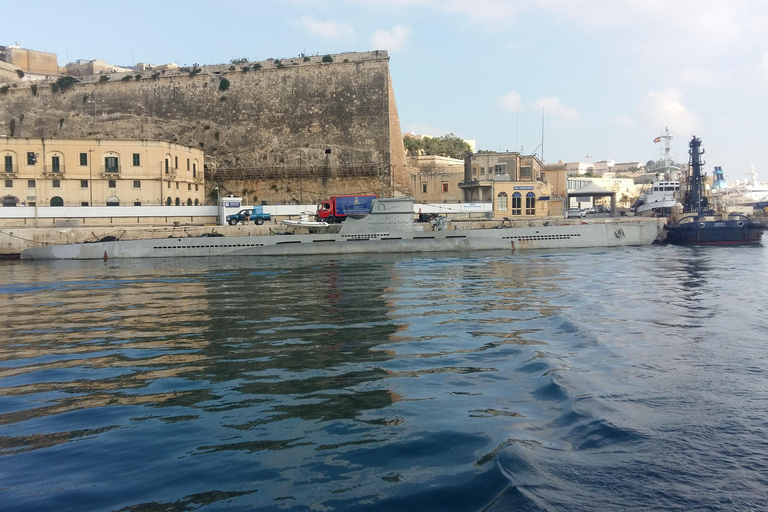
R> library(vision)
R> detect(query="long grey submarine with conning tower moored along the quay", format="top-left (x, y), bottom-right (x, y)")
top-left (21, 198), bottom-right (663, 260)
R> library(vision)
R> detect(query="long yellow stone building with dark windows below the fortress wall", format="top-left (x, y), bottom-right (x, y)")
top-left (0, 137), bottom-right (205, 206)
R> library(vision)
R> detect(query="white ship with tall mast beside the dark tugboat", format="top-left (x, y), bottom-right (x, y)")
top-left (630, 128), bottom-right (680, 217)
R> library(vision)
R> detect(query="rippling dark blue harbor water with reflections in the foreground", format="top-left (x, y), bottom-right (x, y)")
top-left (0, 246), bottom-right (768, 512)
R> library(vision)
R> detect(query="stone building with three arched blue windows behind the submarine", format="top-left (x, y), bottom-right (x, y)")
top-left (459, 152), bottom-right (556, 219)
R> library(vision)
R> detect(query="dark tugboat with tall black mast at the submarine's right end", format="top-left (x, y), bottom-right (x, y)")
top-left (664, 137), bottom-right (763, 245)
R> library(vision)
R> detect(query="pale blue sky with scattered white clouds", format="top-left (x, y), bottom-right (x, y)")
top-left (0, 0), bottom-right (768, 181)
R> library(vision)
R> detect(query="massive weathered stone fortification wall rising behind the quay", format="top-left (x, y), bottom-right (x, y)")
top-left (0, 51), bottom-right (402, 203)
